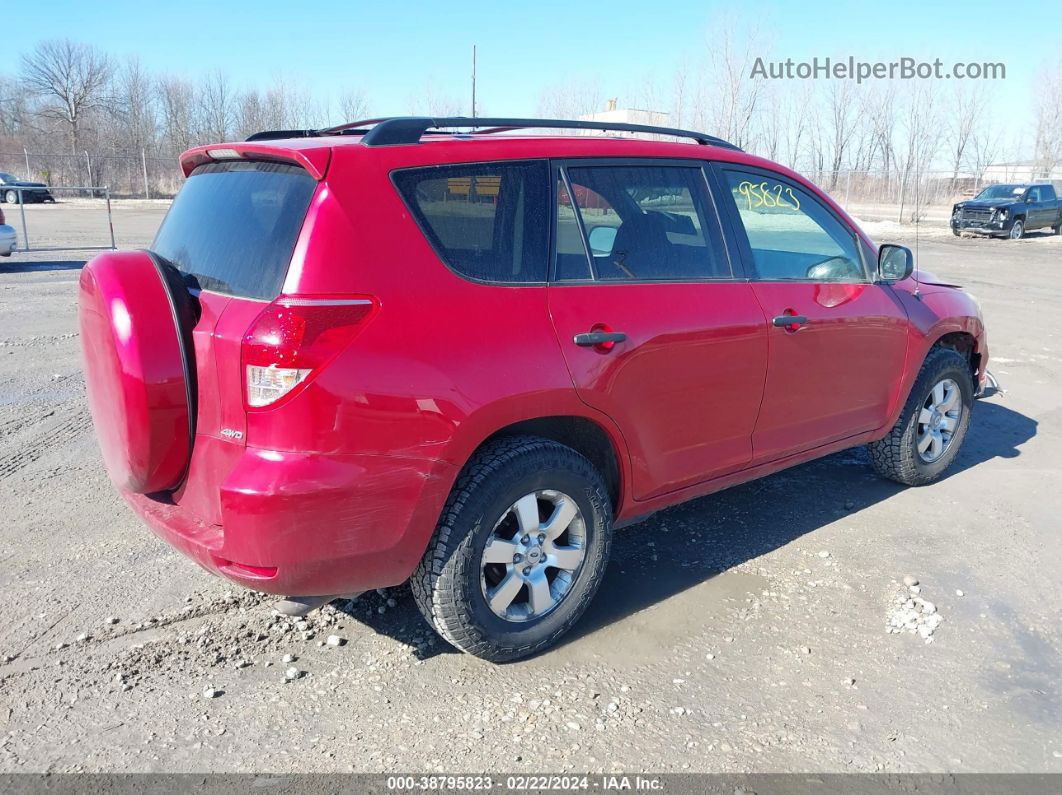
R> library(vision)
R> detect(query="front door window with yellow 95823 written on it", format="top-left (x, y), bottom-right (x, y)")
top-left (723, 169), bottom-right (867, 281)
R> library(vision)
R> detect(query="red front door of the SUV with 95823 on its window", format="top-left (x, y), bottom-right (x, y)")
top-left (716, 163), bottom-right (907, 463)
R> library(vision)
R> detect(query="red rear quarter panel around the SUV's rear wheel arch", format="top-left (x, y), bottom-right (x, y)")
top-left (247, 146), bottom-right (628, 532)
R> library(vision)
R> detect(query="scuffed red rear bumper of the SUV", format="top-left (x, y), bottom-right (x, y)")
top-left (123, 437), bottom-right (456, 597)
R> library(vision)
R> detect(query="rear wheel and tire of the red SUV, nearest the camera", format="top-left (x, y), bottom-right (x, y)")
top-left (410, 436), bottom-right (612, 662)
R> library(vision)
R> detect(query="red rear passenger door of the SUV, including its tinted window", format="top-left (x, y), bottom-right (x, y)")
top-left (549, 160), bottom-right (767, 499)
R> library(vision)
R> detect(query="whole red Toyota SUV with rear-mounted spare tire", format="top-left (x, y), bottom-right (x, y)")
top-left (80, 118), bottom-right (988, 661)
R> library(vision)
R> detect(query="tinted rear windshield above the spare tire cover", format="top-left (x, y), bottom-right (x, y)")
top-left (152, 160), bottom-right (316, 300)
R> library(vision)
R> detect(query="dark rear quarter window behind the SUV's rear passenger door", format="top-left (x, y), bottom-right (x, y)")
top-left (393, 160), bottom-right (550, 283)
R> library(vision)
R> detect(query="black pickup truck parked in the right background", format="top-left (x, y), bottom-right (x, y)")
top-left (952, 185), bottom-right (1062, 240)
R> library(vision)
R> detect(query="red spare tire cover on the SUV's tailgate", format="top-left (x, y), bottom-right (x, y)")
top-left (79, 252), bottom-right (195, 494)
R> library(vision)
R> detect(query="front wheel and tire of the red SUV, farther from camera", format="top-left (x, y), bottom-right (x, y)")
top-left (867, 348), bottom-right (974, 486)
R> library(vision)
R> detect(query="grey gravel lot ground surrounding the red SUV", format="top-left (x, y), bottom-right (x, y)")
top-left (0, 203), bottom-right (1062, 773)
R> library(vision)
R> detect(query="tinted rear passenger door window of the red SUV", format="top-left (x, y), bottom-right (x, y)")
top-left (558, 166), bottom-right (732, 281)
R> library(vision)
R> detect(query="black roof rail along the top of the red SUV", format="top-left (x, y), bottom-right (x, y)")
top-left (247, 116), bottom-right (740, 151)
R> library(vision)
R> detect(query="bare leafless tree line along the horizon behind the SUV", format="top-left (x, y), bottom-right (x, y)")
top-left (0, 36), bottom-right (1062, 201)
